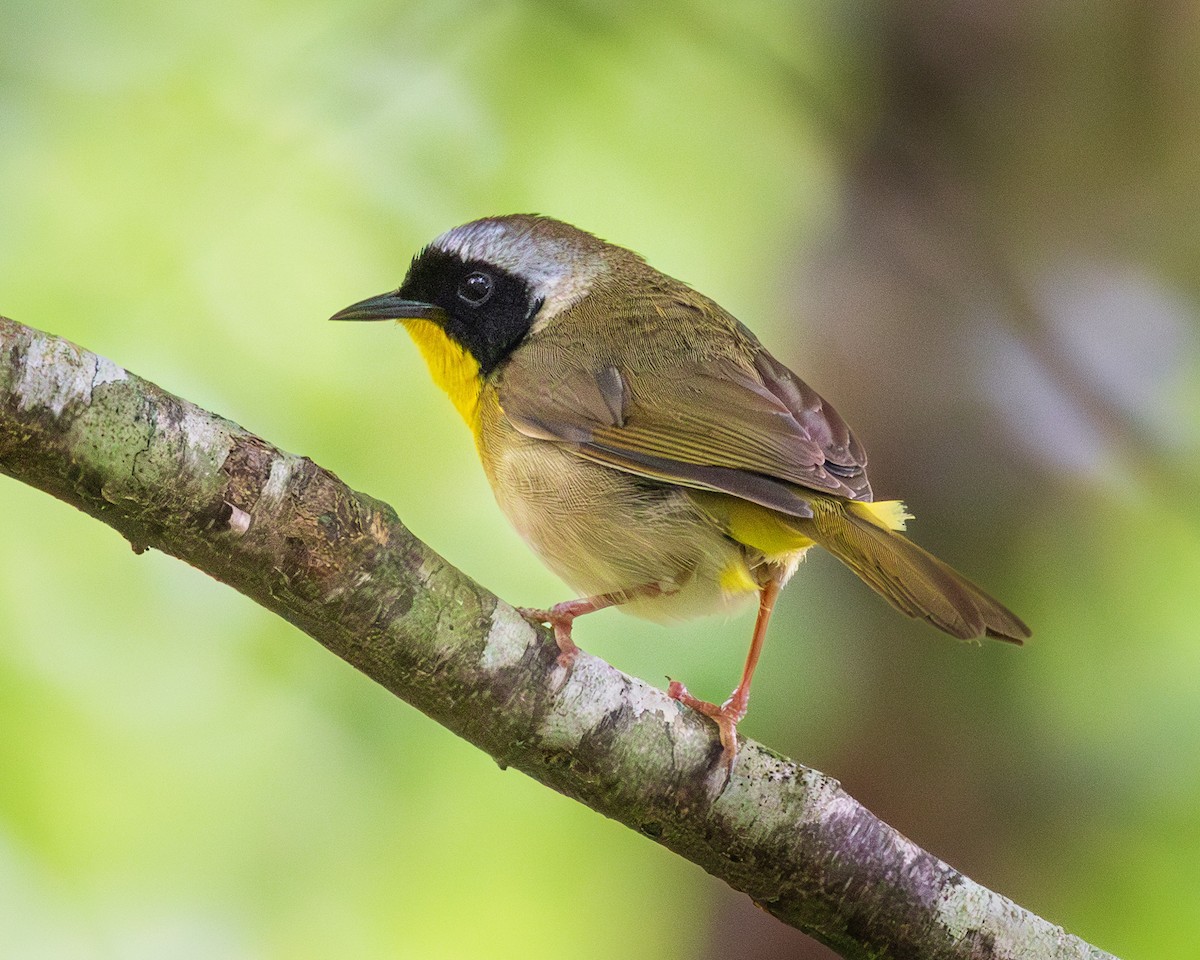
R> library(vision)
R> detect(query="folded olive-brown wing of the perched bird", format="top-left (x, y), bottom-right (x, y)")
top-left (499, 322), bottom-right (871, 517)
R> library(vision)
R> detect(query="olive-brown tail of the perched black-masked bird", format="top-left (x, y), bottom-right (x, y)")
top-left (809, 500), bottom-right (1030, 643)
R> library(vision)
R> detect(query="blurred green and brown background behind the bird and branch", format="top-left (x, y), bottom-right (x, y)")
top-left (0, 0), bottom-right (1200, 960)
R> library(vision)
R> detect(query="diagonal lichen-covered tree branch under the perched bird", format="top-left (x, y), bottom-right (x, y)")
top-left (0, 318), bottom-right (1109, 960)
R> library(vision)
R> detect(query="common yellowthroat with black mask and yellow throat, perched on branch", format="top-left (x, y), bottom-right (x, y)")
top-left (331, 215), bottom-right (1030, 768)
